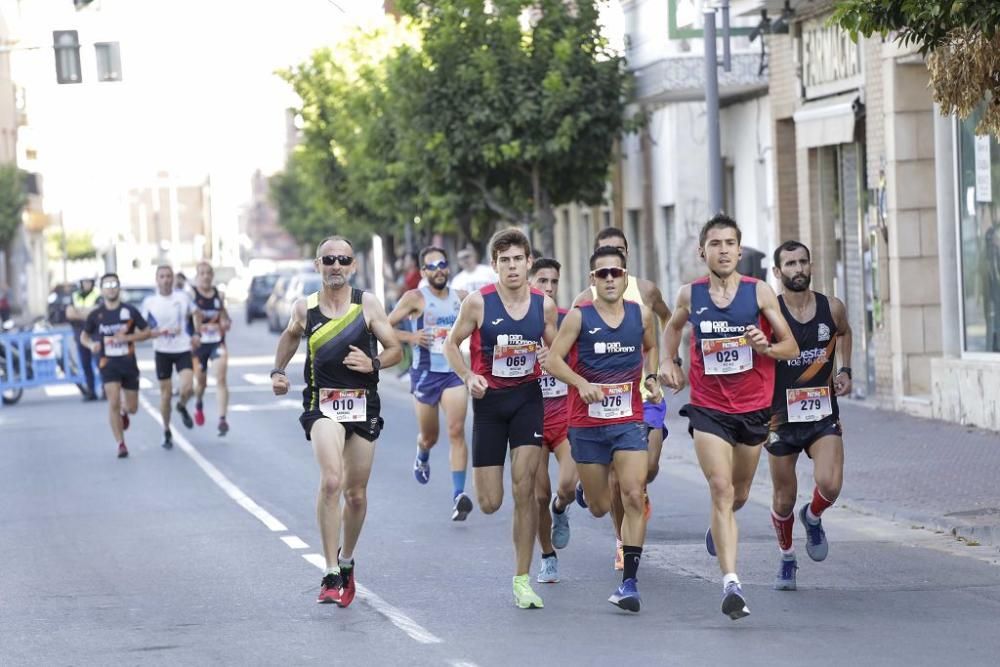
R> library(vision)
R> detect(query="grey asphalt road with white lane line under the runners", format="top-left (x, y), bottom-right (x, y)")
top-left (0, 310), bottom-right (1000, 666)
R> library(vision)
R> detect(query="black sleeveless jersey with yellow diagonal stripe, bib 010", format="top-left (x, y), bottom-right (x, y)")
top-left (302, 288), bottom-right (379, 421)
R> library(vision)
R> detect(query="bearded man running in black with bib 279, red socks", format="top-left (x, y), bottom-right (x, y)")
top-left (764, 241), bottom-right (852, 591)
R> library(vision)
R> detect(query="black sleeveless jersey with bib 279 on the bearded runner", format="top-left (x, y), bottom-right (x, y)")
top-left (771, 292), bottom-right (840, 426)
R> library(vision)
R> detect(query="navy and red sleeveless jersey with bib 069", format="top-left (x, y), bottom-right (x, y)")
top-left (469, 284), bottom-right (545, 389)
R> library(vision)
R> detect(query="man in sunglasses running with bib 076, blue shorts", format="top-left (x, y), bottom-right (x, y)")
top-left (546, 247), bottom-right (661, 612)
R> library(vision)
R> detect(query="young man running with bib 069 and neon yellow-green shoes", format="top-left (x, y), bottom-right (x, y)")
top-left (444, 229), bottom-right (556, 609)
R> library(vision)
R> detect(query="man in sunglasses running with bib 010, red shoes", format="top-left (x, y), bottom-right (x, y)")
top-left (271, 236), bottom-right (403, 607)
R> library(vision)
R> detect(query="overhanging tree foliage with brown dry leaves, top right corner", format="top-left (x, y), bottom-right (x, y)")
top-left (831, 0), bottom-right (1000, 136)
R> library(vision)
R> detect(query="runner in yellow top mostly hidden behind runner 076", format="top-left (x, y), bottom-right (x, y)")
top-left (574, 227), bottom-right (670, 570)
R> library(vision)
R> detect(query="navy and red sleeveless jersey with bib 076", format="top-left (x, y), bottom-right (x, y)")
top-left (569, 301), bottom-right (644, 426)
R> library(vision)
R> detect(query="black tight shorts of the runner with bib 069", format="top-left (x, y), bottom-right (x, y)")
top-left (472, 380), bottom-right (545, 468)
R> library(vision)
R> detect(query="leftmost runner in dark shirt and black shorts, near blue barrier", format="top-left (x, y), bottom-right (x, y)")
top-left (80, 273), bottom-right (153, 459)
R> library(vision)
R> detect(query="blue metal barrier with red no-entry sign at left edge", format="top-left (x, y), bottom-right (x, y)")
top-left (0, 327), bottom-right (86, 405)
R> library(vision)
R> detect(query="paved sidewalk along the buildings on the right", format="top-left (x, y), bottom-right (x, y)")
top-left (663, 392), bottom-right (1000, 548)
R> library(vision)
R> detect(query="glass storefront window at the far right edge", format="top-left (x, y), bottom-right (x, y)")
top-left (958, 113), bottom-right (1000, 352)
